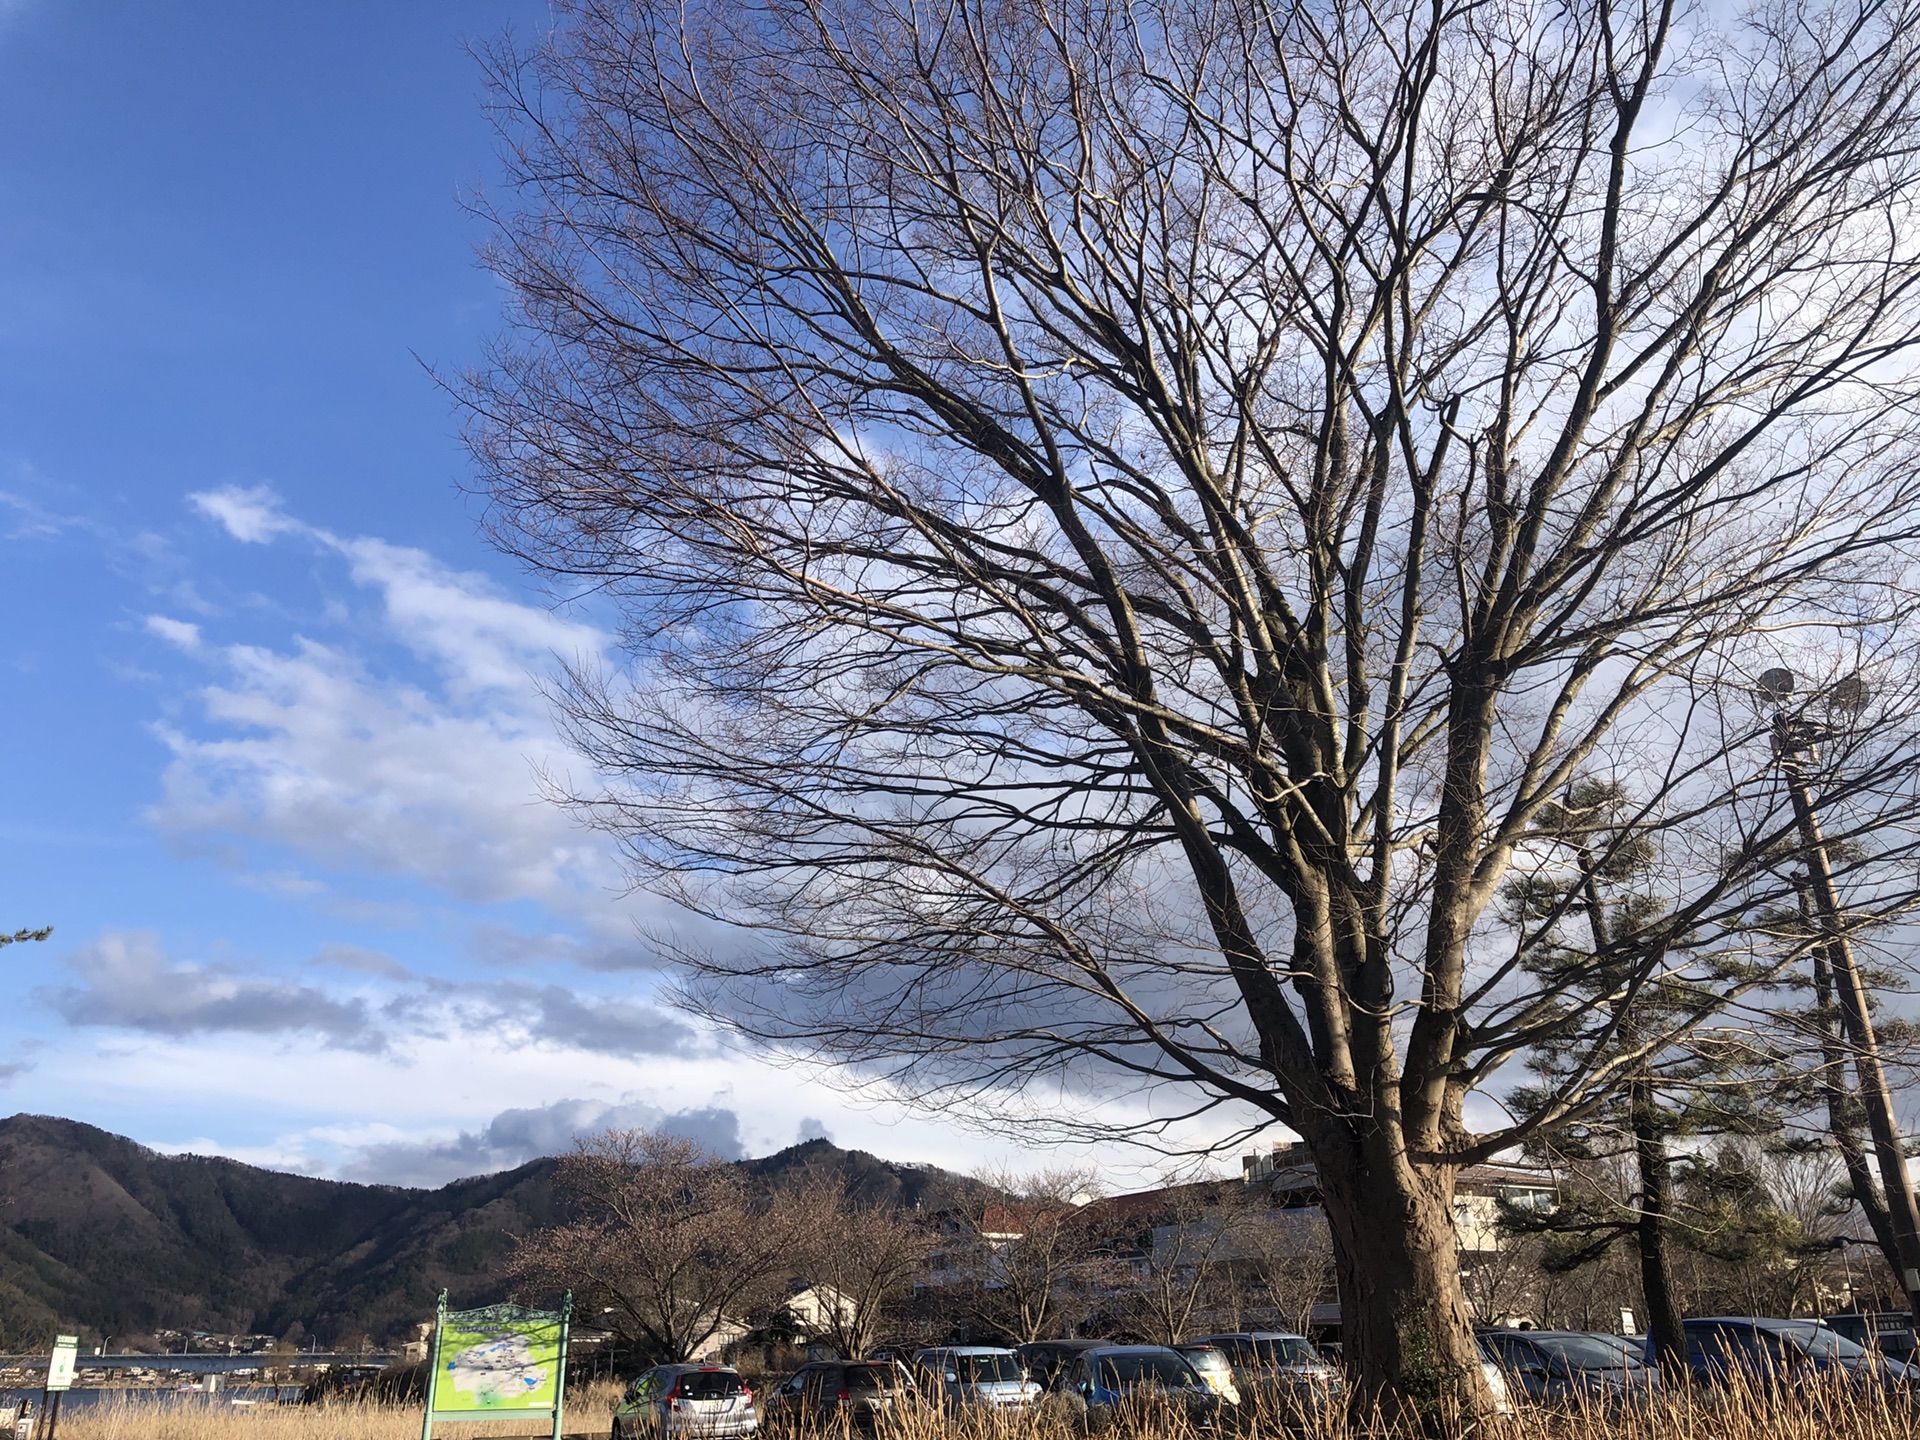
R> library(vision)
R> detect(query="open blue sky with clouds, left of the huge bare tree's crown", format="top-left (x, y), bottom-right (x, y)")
top-left (0, 0), bottom-right (1052, 1183)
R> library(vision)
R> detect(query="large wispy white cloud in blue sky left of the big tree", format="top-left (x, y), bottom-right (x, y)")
top-left (150, 490), bottom-right (620, 933)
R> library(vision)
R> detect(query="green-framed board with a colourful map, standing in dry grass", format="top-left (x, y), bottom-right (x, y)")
top-left (420, 1290), bottom-right (574, 1440)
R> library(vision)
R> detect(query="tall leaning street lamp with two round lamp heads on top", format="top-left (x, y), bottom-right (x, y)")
top-left (1759, 666), bottom-right (1920, 1325)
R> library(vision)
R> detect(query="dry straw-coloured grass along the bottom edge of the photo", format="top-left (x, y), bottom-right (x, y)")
top-left (37, 1384), bottom-right (1920, 1440)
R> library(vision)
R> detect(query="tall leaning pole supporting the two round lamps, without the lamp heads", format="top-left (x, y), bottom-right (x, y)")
top-left (1774, 710), bottom-right (1920, 1325)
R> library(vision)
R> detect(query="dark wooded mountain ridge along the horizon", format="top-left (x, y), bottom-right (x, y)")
top-left (0, 1116), bottom-right (975, 1350)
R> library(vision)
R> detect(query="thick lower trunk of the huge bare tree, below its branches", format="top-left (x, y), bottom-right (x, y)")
top-left (1308, 1137), bottom-right (1494, 1432)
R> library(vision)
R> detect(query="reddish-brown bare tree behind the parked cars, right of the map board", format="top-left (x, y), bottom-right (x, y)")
top-left (513, 1129), bottom-right (806, 1361)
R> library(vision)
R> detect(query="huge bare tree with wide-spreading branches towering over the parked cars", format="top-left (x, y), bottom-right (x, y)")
top-left (467, 0), bottom-right (1920, 1409)
